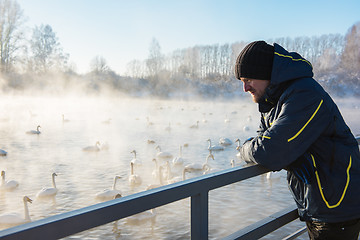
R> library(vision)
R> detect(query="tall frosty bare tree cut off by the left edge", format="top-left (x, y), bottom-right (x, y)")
top-left (0, 0), bottom-right (25, 72)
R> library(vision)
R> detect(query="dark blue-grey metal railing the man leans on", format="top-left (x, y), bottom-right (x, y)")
top-left (0, 165), bottom-right (306, 240)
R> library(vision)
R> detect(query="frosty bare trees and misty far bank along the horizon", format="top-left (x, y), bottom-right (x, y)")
top-left (0, 0), bottom-right (360, 98)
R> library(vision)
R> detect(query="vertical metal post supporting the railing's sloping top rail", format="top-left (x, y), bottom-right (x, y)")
top-left (191, 191), bottom-right (209, 240)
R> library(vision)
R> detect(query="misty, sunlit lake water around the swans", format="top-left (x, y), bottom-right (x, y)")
top-left (0, 96), bottom-right (360, 239)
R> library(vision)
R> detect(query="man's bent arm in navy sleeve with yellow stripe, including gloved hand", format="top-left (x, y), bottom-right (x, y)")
top-left (240, 89), bottom-right (331, 171)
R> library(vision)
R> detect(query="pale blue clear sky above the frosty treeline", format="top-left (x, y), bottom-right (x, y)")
top-left (17, 0), bottom-right (360, 75)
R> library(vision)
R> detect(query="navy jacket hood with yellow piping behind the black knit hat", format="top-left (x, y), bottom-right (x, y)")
top-left (270, 43), bottom-right (314, 85)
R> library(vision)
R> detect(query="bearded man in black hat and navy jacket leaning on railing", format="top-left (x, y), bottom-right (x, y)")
top-left (235, 41), bottom-right (360, 239)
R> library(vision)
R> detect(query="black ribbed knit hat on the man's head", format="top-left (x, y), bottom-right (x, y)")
top-left (235, 41), bottom-right (274, 80)
